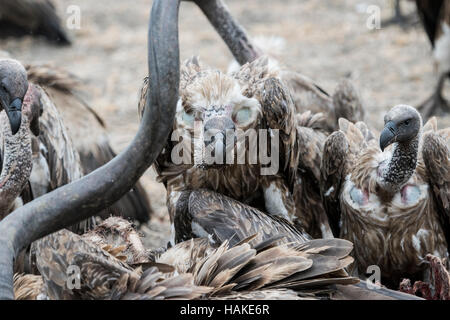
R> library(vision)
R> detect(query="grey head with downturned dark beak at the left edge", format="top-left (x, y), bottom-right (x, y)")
top-left (0, 59), bottom-right (28, 134)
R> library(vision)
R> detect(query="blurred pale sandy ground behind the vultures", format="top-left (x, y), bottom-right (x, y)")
top-left (0, 0), bottom-right (450, 247)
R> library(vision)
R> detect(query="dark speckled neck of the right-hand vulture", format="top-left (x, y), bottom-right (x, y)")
top-left (380, 132), bottom-right (420, 193)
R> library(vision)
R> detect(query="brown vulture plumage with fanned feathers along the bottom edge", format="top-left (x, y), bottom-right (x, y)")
top-left (14, 217), bottom-right (359, 300)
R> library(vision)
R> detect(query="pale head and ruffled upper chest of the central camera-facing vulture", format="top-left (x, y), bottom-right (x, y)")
top-left (174, 58), bottom-right (262, 170)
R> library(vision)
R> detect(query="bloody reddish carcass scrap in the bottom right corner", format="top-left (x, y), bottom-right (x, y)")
top-left (400, 254), bottom-right (450, 300)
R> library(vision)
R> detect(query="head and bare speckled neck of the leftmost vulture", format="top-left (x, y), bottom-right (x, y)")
top-left (0, 60), bottom-right (39, 220)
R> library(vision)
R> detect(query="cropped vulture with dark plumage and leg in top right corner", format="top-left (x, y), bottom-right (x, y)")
top-left (416, 0), bottom-right (450, 119)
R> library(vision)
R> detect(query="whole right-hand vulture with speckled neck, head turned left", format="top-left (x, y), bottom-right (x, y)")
top-left (321, 105), bottom-right (450, 288)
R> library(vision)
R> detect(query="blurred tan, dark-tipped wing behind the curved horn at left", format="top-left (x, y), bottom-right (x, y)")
top-left (26, 65), bottom-right (152, 222)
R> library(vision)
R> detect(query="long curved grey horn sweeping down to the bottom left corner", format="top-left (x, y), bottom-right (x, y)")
top-left (0, 0), bottom-right (180, 299)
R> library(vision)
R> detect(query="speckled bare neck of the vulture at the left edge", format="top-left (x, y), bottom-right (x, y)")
top-left (0, 112), bottom-right (32, 220)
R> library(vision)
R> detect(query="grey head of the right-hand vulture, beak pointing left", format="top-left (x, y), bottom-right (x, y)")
top-left (380, 105), bottom-right (422, 151)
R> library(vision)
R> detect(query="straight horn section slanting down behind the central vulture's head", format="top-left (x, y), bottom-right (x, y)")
top-left (193, 0), bottom-right (260, 65)
